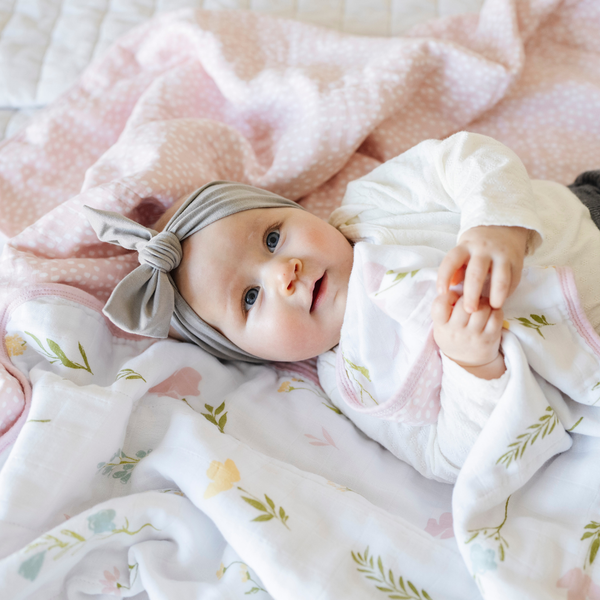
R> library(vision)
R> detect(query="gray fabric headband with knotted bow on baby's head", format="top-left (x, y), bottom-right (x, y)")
top-left (83, 181), bottom-right (302, 362)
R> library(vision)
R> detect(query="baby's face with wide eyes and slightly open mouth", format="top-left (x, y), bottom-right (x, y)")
top-left (175, 208), bottom-right (353, 361)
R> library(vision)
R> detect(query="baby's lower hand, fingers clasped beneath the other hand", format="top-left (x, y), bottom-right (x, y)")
top-left (431, 291), bottom-right (506, 379)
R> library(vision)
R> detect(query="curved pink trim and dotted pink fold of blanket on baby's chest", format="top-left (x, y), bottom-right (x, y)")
top-left (336, 327), bottom-right (442, 425)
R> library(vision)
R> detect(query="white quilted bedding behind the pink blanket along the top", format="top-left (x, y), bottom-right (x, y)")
top-left (0, 0), bottom-right (483, 140)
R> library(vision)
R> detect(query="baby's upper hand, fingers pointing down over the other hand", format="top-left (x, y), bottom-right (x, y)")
top-left (437, 226), bottom-right (529, 313)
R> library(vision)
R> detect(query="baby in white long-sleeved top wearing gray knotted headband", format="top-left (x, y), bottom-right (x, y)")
top-left (88, 133), bottom-right (600, 481)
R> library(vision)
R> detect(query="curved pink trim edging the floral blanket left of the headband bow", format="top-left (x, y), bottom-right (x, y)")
top-left (0, 283), bottom-right (154, 453)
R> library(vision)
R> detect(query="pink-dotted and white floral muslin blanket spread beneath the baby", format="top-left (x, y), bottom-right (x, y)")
top-left (0, 0), bottom-right (600, 600)
